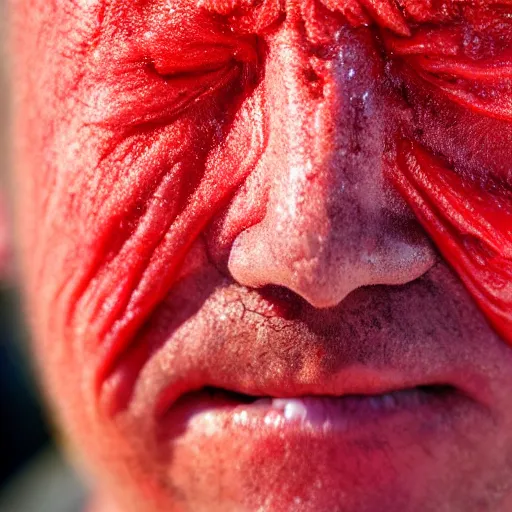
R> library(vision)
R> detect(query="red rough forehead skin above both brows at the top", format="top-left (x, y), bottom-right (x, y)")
top-left (11, 0), bottom-right (512, 56)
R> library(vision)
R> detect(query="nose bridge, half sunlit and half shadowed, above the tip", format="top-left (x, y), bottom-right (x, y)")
top-left (262, 27), bottom-right (383, 252)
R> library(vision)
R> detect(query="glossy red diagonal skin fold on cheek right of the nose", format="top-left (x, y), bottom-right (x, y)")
top-left (390, 142), bottom-right (512, 344)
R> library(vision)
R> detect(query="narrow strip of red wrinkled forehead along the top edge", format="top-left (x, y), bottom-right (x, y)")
top-left (10, 0), bottom-right (512, 45)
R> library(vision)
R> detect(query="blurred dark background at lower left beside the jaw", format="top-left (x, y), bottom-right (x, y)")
top-left (0, 284), bottom-right (86, 512)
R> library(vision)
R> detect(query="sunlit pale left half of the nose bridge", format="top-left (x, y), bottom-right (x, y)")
top-left (262, 30), bottom-right (333, 247)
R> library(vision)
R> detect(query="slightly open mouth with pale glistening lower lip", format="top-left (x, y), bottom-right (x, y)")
top-left (160, 384), bottom-right (470, 433)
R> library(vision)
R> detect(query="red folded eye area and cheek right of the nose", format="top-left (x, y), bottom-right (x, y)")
top-left (385, 8), bottom-right (512, 344)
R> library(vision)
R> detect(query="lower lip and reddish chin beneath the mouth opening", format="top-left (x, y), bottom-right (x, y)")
top-left (158, 388), bottom-right (477, 511)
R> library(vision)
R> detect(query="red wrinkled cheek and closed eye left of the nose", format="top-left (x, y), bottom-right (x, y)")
top-left (15, 1), bottom-right (261, 390)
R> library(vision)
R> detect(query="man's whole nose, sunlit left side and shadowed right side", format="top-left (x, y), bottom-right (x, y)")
top-left (228, 26), bottom-right (435, 308)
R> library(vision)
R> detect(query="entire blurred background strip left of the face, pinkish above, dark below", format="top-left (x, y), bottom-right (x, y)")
top-left (0, 4), bottom-right (85, 512)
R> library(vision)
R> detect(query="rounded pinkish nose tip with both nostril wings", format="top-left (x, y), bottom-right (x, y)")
top-left (228, 215), bottom-right (436, 308)
